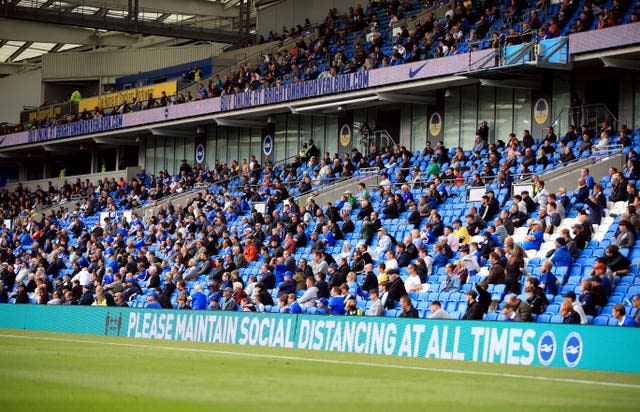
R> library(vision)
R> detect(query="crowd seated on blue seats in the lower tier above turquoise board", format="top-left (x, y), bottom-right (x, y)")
top-left (0, 116), bottom-right (640, 326)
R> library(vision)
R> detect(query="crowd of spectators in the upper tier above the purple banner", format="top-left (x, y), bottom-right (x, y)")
top-left (6, 0), bottom-right (640, 133)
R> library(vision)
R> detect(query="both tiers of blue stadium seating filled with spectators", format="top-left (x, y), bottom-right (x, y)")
top-left (0, 1), bottom-right (640, 326)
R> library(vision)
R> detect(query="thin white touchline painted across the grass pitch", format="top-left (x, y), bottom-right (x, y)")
top-left (0, 334), bottom-right (640, 389)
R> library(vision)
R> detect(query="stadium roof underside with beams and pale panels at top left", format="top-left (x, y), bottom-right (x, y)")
top-left (0, 0), bottom-right (254, 63)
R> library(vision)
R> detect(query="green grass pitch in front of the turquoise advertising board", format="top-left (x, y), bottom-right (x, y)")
top-left (0, 329), bottom-right (640, 412)
